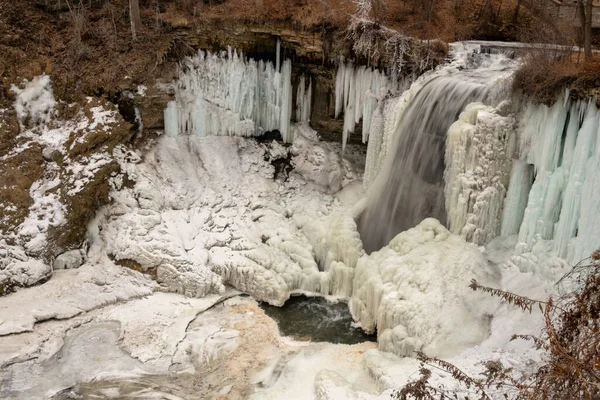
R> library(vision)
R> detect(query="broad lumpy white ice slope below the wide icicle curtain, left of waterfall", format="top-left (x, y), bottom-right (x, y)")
top-left (98, 125), bottom-right (361, 305)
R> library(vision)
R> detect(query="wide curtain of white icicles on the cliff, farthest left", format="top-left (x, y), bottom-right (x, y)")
top-left (165, 48), bottom-right (293, 142)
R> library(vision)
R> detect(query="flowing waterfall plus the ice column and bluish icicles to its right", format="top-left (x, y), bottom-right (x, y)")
top-left (358, 45), bottom-right (600, 263)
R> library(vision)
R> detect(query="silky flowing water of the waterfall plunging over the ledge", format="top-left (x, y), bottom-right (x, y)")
top-left (359, 48), bottom-right (514, 252)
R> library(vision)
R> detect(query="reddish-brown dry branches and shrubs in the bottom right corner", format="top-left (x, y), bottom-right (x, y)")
top-left (393, 250), bottom-right (600, 400)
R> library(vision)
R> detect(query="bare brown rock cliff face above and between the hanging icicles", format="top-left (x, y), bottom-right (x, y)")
top-left (132, 22), bottom-right (352, 137)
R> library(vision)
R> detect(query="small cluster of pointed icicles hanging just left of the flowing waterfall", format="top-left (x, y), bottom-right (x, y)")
top-left (335, 58), bottom-right (392, 152)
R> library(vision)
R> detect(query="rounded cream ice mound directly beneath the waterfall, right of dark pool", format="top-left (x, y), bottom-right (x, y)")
top-left (350, 219), bottom-right (498, 356)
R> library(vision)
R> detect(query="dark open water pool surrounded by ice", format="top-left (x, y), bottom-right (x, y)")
top-left (260, 296), bottom-right (377, 344)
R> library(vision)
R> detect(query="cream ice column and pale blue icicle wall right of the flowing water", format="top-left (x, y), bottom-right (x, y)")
top-left (445, 96), bottom-right (600, 263)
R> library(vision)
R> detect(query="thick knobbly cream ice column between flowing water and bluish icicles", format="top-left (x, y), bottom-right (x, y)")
top-left (444, 103), bottom-right (515, 244)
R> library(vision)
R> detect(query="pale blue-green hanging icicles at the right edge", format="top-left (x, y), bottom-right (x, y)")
top-left (503, 96), bottom-right (600, 262)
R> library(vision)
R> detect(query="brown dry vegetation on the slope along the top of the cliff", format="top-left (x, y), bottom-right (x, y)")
top-left (0, 0), bottom-right (592, 104)
